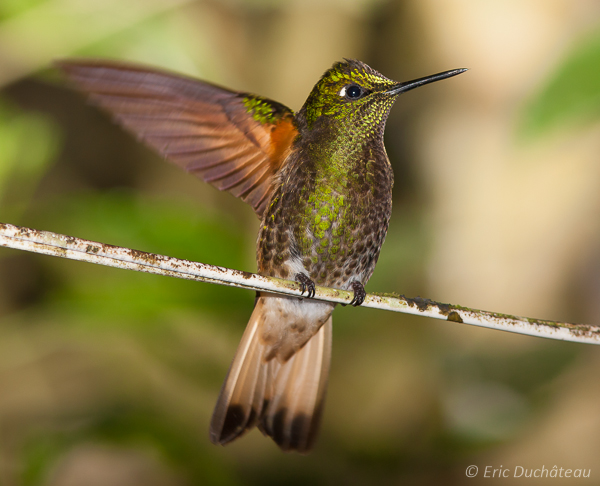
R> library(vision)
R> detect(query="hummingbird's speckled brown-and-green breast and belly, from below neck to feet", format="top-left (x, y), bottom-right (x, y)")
top-left (257, 148), bottom-right (393, 288)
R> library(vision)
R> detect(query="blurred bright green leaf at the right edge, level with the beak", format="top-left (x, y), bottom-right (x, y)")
top-left (519, 24), bottom-right (600, 138)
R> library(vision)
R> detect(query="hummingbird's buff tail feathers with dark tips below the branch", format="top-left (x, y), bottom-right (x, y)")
top-left (210, 299), bottom-right (332, 452)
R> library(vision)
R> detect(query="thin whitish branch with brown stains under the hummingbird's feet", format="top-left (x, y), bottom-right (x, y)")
top-left (0, 223), bottom-right (600, 344)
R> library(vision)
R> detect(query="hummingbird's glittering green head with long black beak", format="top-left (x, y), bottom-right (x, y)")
top-left (298, 59), bottom-right (466, 140)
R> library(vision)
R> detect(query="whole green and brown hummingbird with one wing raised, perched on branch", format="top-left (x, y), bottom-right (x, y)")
top-left (57, 59), bottom-right (466, 453)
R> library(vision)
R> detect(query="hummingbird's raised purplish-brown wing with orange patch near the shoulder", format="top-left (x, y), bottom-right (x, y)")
top-left (56, 60), bottom-right (298, 217)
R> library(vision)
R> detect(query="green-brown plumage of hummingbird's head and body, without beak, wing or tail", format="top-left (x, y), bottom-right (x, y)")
top-left (258, 61), bottom-right (396, 287)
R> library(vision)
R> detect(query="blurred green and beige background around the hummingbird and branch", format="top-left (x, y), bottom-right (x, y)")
top-left (0, 0), bottom-right (600, 486)
